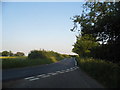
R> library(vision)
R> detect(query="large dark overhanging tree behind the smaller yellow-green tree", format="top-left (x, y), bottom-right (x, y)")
top-left (71, 2), bottom-right (120, 62)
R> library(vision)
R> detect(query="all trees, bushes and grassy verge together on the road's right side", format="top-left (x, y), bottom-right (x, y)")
top-left (71, 0), bottom-right (120, 88)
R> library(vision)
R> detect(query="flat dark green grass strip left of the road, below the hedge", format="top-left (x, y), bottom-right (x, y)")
top-left (2, 58), bottom-right (53, 69)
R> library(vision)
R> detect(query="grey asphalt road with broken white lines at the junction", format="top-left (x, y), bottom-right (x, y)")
top-left (2, 58), bottom-right (103, 89)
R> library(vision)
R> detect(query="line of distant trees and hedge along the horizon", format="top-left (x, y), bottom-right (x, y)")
top-left (0, 49), bottom-right (76, 58)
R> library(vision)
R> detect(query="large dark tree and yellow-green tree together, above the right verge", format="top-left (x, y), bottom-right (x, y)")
top-left (71, 2), bottom-right (120, 63)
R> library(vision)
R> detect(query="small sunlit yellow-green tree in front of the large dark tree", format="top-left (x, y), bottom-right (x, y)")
top-left (72, 34), bottom-right (99, 57)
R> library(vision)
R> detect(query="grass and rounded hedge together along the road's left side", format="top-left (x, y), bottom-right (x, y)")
top-left (2, 50), bottom-right (70, 69)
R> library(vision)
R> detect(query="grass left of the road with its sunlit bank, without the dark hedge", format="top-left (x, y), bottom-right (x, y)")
top-left (2, 52), bottom-right (69, 69)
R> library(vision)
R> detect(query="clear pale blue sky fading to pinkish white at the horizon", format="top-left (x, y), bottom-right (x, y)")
top-left (2, 2), bottom-right (83, 55)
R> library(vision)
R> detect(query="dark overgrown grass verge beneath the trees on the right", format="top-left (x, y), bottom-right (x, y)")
top-left (77, 58), bottom-right (120, 88)
